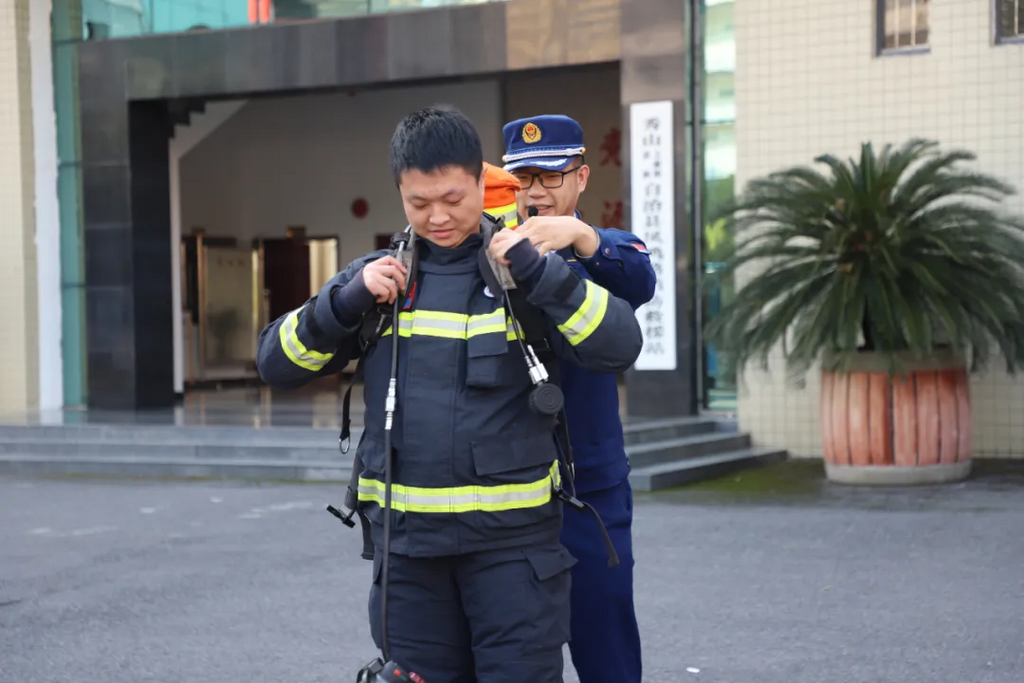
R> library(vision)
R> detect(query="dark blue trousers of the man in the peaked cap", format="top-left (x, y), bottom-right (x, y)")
top-left (562, 479), bottom-right (642, 683)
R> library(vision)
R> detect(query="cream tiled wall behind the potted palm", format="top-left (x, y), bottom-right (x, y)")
top-left (735, 0), bottom-right (1024, 458)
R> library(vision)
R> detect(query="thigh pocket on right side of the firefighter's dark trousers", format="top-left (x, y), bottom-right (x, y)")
top-left (523, 544), bottom-right (577, 653)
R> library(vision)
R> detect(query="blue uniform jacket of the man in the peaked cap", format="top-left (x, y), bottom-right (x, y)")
top-left (559, 212), bottom-right (656, 493)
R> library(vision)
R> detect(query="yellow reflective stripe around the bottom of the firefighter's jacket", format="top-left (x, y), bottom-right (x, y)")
top-left (358, 461), bottom-right (560, 513)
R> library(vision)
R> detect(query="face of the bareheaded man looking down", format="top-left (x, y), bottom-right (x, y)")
top-left (398, 166), bottom-right (483, 247)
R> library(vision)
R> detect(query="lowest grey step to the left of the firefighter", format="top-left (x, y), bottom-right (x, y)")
top-left (0, 455), bottom-right (351, 483)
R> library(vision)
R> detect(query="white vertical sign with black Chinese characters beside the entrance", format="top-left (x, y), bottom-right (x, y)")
top-left (630, 100), bottom-right (677, 370)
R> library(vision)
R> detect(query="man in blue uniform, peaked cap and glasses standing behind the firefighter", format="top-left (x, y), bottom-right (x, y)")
top-left (503, 115), bottom-right (655, 683)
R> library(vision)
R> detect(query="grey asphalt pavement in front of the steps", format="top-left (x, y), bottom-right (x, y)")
top-left (0, 466), bottom-right (1024, 683)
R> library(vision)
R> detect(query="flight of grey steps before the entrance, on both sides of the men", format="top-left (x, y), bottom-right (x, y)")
top-left (0, 417), bottom-right (782, 490)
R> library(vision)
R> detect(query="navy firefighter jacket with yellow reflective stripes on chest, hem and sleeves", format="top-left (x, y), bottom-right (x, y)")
top-left (257, 220), bottom-right (643, 557)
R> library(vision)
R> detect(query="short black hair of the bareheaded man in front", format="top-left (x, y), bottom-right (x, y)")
top-left (391, 104), bottom-right (483, 185)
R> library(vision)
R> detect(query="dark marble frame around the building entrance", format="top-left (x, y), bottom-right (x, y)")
top-left (77, 0), bottom-right (695, 415)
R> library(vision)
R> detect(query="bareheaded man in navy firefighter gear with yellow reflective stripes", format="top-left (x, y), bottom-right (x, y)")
top-left (257, 108), bottom-right (642, 683)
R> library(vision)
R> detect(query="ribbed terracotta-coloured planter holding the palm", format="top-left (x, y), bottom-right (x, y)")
top-left (821, 353), bottom-right (971, 485)
